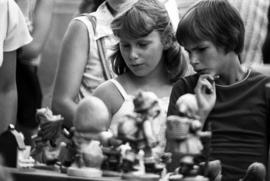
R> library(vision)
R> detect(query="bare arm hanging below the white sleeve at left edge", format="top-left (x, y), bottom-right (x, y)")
top-left (0, 51), bottom-right (17, 134)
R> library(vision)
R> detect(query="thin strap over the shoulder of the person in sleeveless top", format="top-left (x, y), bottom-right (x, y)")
top-left (82, 13), bottom-right (113, 80)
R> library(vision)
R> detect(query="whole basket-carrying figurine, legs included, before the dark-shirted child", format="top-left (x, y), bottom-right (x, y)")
top-left (166, 94), bottom-right (211, 180)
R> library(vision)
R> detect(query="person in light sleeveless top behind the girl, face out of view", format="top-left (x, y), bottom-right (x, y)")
top-left (52, 0), bottom-right (136, 127)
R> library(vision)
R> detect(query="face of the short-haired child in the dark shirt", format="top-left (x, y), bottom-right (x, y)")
top-left (184, 41), bottom-right (227, 75)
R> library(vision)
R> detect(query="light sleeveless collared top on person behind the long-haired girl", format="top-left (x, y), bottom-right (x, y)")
top-left (75, 3), bottom-right (118, 102)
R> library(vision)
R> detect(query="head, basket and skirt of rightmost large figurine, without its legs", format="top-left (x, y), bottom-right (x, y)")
top-left (166, 94), bottom-right (203, 155)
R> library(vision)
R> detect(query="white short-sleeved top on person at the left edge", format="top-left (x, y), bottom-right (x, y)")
top-left (0, 0), bottom-right (32, 67)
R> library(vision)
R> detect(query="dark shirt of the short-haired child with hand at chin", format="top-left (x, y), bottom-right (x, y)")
top-left (168, 71), bottom-right (270, 181)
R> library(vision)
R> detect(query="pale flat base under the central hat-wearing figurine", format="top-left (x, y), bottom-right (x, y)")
top-left (122, 173), bottom-right (160, 181)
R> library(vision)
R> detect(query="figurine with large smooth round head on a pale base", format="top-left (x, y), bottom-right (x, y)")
top-left (67, 96), bottom-right (109, 177)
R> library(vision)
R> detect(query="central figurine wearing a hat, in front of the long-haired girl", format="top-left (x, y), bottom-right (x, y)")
top-left (117, 92), bottom-right (169, 178)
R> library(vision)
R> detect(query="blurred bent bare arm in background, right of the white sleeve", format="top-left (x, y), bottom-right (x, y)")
top-left (20, 0), bottom-right (54, 60)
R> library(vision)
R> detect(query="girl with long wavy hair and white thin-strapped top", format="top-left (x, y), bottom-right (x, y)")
top-left (94, 0), bottom-right (187, 152)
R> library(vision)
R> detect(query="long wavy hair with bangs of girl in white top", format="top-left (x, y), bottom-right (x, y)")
top-left (111, 0), bottom-right (187, 82)
